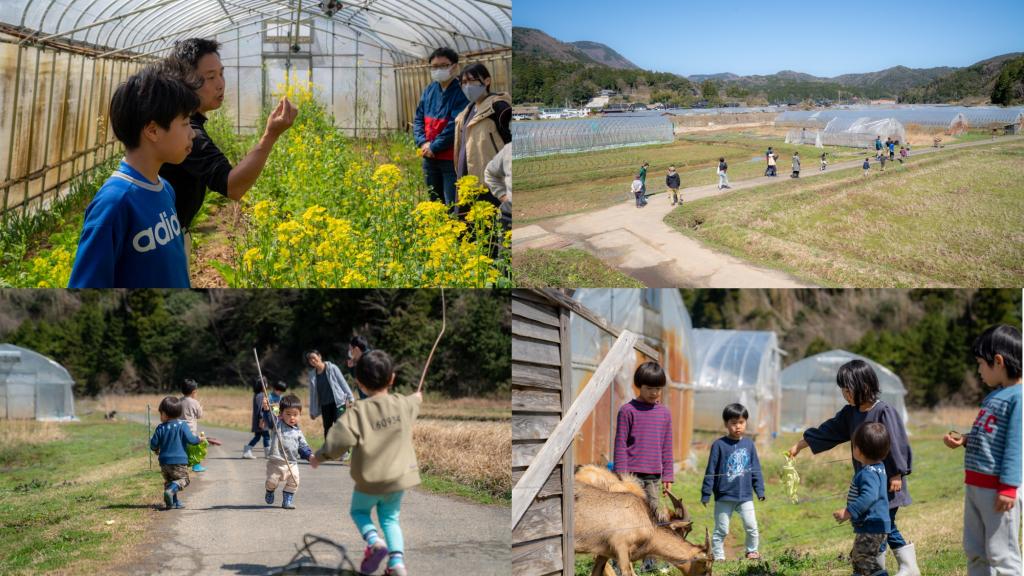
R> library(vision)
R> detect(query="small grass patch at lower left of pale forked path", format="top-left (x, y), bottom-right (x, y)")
top-left (512, 248), bottom-right (644, 288)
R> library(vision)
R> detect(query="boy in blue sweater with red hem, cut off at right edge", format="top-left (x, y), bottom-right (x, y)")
top-left (943, 325), bottom-right (1021, 576)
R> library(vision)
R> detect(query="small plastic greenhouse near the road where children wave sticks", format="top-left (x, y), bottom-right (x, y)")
top-left (0, 344), bottom-right (75, 420)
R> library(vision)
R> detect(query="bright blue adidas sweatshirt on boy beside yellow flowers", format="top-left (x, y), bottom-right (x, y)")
top-left (68, 160), bottom-right (188, 288)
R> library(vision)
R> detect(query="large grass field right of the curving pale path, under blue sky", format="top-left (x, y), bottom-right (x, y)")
top-left (666, 140), bottom-right (1024, 287)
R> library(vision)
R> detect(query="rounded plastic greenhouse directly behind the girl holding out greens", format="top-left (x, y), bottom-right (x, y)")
top-left (782, 349), bottom-right (907, 431)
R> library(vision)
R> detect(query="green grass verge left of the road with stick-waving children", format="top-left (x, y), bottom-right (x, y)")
top-left (0, 418), bottom-right (155, 574)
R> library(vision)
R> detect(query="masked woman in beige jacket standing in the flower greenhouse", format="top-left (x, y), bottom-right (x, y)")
top-left (455, 64), bottom-right (512, 211)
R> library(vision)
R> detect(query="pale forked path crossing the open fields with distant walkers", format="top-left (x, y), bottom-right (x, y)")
top-left (512, 136), bottom-right (1019, 288)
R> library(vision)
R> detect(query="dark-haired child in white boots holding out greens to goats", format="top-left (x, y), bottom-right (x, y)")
top-left (790, 360), bottom-right (921, 576)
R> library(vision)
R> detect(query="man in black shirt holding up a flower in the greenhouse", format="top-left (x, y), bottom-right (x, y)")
top-left (160, 38), bottom-right (298, 266)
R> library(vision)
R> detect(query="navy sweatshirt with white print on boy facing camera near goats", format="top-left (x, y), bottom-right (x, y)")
top-left (700, 436), bottom-right (765, 503)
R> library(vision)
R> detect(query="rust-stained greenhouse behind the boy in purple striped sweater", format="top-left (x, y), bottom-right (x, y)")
top-left (570, 288), bottom-right (694, 467)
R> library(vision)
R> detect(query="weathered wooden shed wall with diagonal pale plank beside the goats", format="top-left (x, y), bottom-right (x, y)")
top-left (512, 289), bottom-right (658, 576)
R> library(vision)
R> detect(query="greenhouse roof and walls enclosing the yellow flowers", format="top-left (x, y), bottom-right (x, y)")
top-left (0, 0), bottom-right (512, 219)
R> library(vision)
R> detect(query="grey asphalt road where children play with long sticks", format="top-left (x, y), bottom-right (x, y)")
top-left (114, 417), bottom-right (512, 575)
